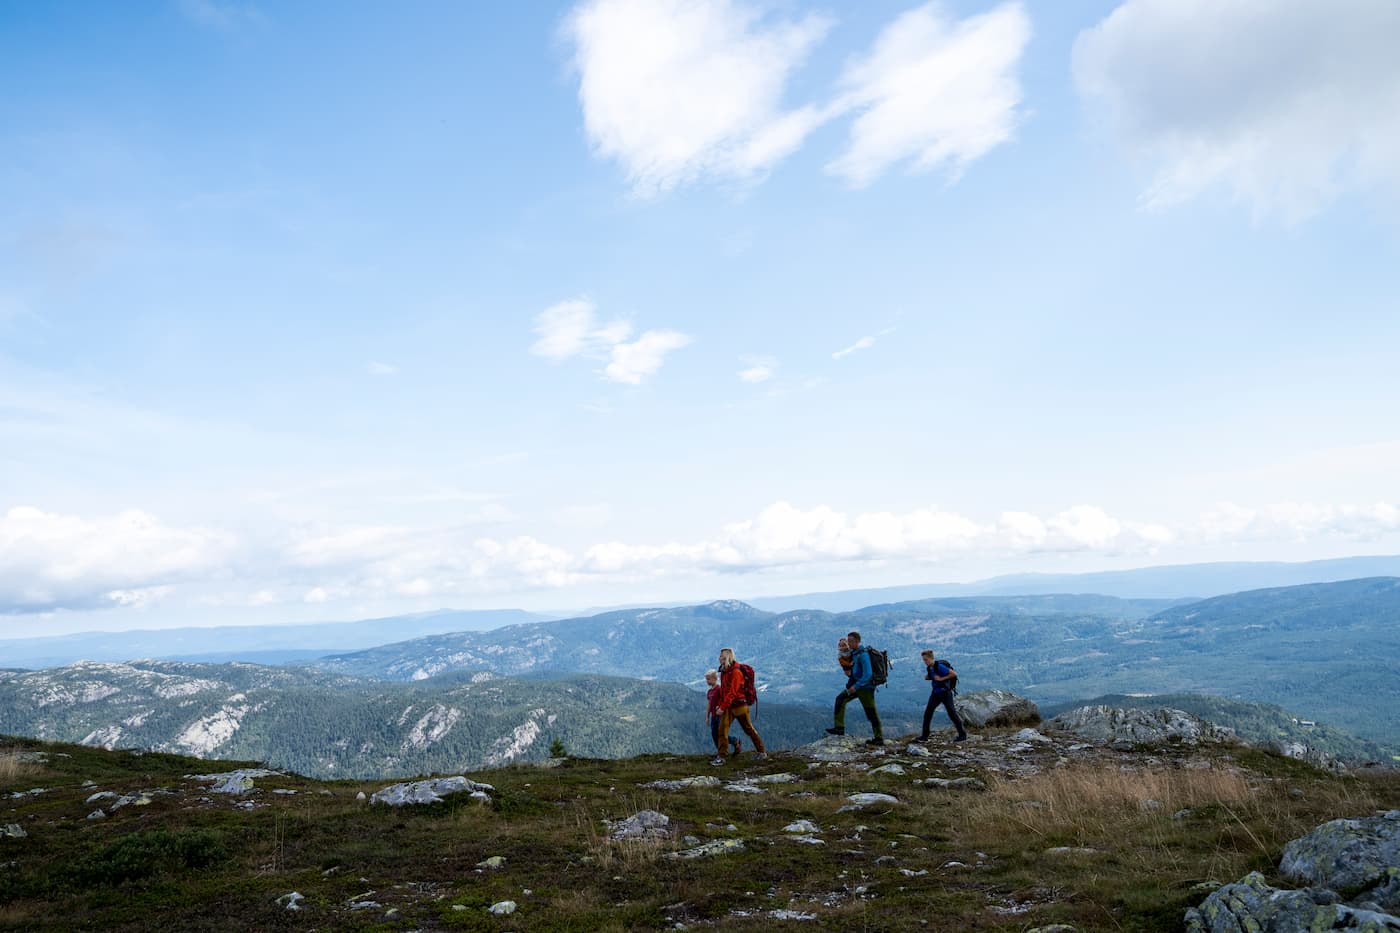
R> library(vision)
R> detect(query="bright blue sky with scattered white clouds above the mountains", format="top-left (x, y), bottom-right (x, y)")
top-left (0, 0), bottom-right (1400, 637)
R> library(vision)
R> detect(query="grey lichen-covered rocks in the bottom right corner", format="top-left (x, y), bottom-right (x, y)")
top-left (1186, 810), bottom-right (1400, 933)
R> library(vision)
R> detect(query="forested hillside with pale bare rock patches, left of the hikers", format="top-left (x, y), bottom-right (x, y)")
top-left (0, 661), bottom-right (826, 778)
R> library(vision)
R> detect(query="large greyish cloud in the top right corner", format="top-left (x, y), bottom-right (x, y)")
top-left (1074, 0), bottom-right (1400, 221)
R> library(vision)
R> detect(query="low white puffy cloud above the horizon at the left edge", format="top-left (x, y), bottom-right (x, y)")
top-left (0, 506), bottom-right (234, 612)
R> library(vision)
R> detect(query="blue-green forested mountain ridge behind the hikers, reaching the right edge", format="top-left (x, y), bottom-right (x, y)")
top-left (306, 577), bottom-right (1400, 744)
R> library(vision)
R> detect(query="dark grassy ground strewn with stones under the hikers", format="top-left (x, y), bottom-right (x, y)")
top-left (0, 730), bottom-right (1400, 930)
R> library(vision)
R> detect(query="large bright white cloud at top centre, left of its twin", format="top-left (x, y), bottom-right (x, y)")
top-left (564, 0), bottom-right (830, 196)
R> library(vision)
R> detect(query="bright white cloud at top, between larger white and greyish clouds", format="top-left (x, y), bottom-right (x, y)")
top-left (827, 3), bottom-right (1030, 186)
